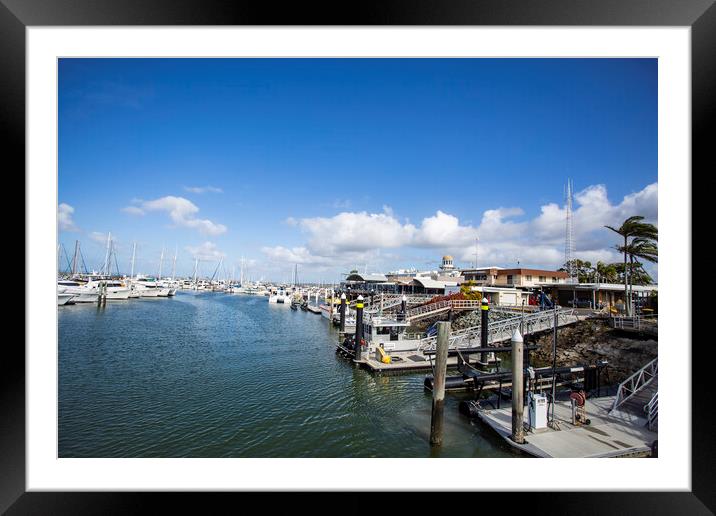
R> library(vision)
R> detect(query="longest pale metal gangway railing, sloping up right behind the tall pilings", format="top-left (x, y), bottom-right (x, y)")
top-left (418, 308), bottom-right (578, 351)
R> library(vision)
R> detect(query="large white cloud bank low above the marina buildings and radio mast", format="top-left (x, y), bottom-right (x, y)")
top-left (263, 183), bottom-right (658, 268)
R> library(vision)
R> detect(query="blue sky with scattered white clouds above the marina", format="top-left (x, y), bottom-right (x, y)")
top-left (58, 59), bottom-right (657, 281)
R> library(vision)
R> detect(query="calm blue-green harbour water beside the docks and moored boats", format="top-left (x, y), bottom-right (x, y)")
top-left (58, 292), bottom-right (515, 457)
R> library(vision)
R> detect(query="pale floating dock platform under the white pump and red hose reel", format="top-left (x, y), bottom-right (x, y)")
top-left (478, 396), bottom-right (658, 458)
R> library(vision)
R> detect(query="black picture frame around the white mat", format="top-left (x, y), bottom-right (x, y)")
top-left (0, 0), bottom-right (716, 514)
